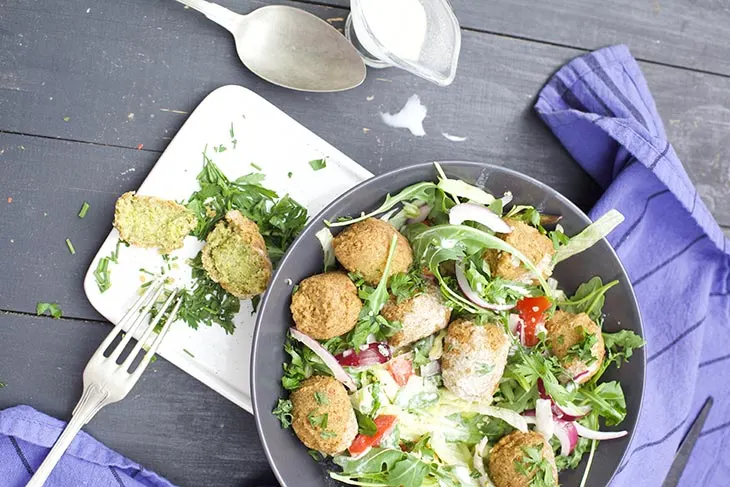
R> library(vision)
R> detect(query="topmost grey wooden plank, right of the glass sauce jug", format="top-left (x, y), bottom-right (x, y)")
top-left (322, 0), bottom-right (730, 75)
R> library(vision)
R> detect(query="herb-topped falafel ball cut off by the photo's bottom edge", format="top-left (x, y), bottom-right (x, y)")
top-left (489, 431), bottom-right (558, 487)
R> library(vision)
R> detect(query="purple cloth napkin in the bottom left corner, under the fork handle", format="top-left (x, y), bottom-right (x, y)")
top-left (0, 406), bottom-right (174, 487)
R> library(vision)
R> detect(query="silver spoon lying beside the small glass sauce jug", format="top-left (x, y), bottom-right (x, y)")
top-left (177, 0), bottom-right (365, 92)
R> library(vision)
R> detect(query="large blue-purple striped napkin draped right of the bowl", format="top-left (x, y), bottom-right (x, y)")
top-left (535, 46), bottom-right (730, 487)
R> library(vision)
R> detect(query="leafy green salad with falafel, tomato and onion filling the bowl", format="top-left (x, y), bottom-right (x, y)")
top-left (274, 163), bottom-right (644, 487)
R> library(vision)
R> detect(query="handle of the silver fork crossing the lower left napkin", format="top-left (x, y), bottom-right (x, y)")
top-left (26, 384), bottom-right (109, 487)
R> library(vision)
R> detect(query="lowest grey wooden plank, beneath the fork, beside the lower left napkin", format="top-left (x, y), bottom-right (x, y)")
top-left (0, 313), bottom-right (276, 487)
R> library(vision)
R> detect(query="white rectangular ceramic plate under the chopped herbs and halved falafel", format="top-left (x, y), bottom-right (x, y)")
top-left (84, 85), bottom-right (372, 412)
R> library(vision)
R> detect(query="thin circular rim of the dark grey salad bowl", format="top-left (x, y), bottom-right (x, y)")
top-left (249, 160), bottom-right (646, 487)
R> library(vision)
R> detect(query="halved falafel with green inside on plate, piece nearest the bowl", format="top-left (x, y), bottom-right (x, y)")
top-left (203, 210), bottom-right (272, 299)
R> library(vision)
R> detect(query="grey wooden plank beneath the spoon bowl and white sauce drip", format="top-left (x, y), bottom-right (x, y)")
top-left (0, 0), bottom-right (730, 231)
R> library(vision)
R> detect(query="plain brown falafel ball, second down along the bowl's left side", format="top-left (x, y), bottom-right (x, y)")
top-left (291, 272), bottom-right (362, 340)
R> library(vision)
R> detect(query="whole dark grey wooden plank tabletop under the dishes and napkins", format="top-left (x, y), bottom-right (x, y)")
top-left (0, 0), bottom-right (730, 486)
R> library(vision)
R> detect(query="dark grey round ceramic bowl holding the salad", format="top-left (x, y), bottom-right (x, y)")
top-left (251, 162), bottom-right (645, 487)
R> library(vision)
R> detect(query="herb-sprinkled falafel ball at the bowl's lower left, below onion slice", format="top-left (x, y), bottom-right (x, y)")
top-left (290, 375), bottom-right (357, 455)
